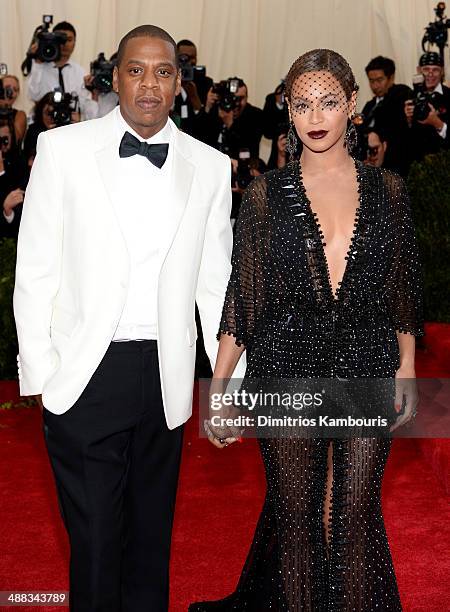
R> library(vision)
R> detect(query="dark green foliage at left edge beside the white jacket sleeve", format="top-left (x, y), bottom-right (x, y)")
top-left (0, 238), bottom-right (17, 380)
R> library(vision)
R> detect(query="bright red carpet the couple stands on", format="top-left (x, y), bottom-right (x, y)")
top-left (0, 322), bottom-right (450, 612)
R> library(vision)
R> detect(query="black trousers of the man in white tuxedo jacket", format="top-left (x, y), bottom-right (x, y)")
top-left (44, 340), bottom-right (183, 612)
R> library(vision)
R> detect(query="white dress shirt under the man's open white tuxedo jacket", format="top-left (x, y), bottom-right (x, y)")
top-left (113, 107), bottom-right (173, 341)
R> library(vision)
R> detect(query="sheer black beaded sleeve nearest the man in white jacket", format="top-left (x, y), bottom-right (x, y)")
top-left (217, 177), bottom-right (268, 348)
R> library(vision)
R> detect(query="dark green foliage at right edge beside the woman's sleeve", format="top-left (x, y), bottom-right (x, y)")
top-left (408, 151), bottom-right (450, 323)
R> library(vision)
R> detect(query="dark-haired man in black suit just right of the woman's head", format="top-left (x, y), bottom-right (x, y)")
top-left (362, 55), bottom-right (412, 175)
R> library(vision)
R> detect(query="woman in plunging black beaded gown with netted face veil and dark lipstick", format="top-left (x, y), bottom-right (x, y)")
top-left (189, 49), bottom-right (423, 612)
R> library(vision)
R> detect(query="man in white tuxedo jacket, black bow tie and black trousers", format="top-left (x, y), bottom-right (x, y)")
top-left (14, 26), bottom-right (243, 612)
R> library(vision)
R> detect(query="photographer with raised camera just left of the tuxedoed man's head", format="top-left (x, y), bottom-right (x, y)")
top-left (84, 53), bottom-right (119, 117)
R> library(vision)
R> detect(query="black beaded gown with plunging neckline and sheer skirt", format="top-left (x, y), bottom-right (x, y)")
top-left (189, 162), bottom-right (423, 612)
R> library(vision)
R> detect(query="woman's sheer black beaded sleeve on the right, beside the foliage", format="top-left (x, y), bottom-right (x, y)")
top-left (385, 172), bottom-right (424, 336)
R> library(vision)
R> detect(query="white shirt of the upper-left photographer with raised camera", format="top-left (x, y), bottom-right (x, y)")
top-left (27, 60), bottom-right (98, 119)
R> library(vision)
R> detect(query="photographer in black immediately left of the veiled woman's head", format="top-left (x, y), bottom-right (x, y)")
top-left (263, 80), bottom-right (289, 168)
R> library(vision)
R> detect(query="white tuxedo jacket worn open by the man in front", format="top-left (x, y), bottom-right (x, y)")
top-left (14, 107), bottom-right (245, 429)
